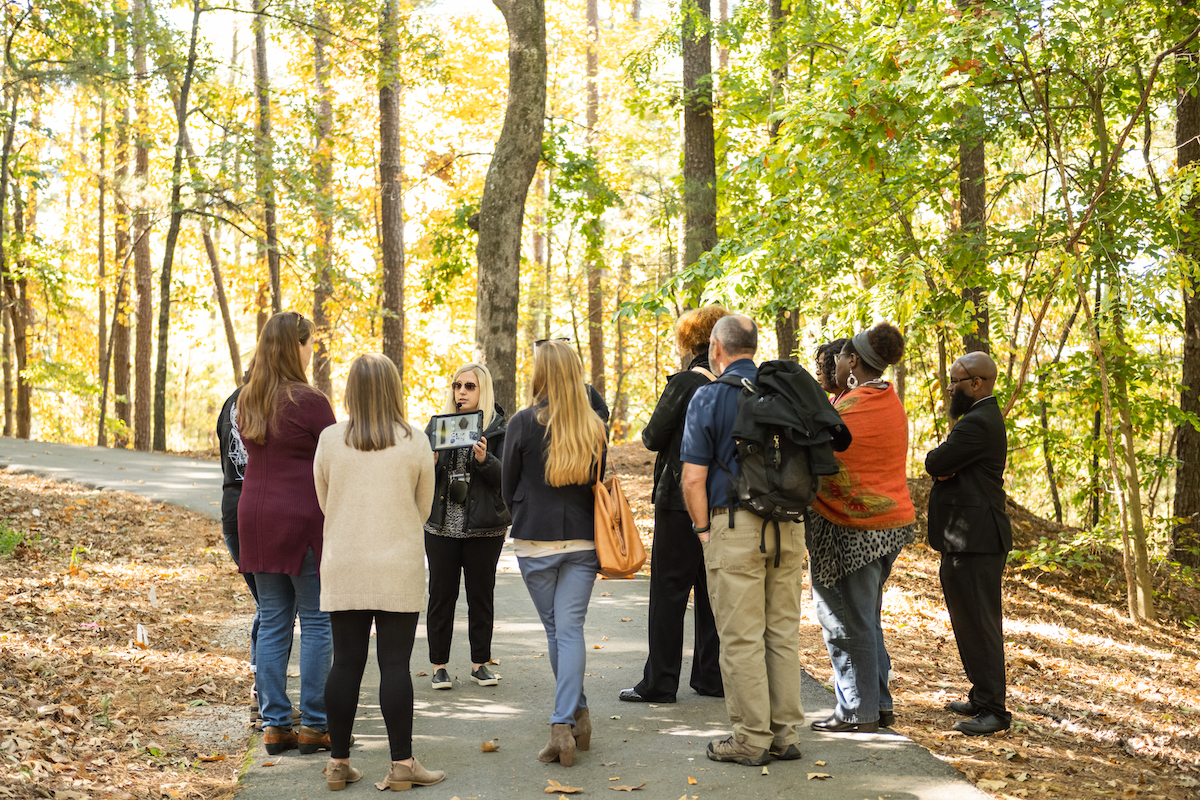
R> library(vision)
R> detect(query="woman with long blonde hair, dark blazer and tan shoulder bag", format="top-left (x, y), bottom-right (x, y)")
top-left (503, 341), bottom-right (607, 766)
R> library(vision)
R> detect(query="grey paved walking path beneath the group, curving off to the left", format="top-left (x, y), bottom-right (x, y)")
top-left (0, 439), bottom-right (986, 800)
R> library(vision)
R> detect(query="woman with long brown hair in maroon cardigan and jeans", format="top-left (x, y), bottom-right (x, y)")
top-left (238, 312), bottom-right (335, 756)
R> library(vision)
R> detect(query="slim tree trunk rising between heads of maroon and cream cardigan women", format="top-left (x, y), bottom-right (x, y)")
top-left (312, 10), bottom-right (334, 397)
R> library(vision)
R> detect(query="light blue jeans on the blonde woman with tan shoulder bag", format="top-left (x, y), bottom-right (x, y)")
top-left (517, 551), bottom-right (600, 724)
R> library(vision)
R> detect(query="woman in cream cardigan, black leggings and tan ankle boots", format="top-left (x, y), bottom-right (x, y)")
top-left (313, 354), bottom-right (445, 790)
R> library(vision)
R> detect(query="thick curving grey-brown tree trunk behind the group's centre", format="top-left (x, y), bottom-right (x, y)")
top-left (475, 0), bottom-right (546, 411)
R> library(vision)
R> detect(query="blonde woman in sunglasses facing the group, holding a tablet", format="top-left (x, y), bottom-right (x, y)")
top-left (425, 363), bottom-right (511, 688)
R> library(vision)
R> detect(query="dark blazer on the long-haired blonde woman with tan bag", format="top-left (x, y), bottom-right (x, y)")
top-left (500, 408), bottom-right (607, 542)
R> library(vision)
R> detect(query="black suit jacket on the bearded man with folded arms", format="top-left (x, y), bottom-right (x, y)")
top-left (925, 397), bottom-right (1013, 553)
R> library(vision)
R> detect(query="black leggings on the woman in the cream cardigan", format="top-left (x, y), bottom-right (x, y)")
top-left (325, 610), bottom-right (420, 762)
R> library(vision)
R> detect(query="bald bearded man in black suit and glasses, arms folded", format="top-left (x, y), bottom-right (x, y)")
top-left (925, 353), bottom-right (1013, 736)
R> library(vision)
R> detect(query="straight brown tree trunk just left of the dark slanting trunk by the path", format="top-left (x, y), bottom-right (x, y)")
top-left (133, 0), bottom-right (154, 450)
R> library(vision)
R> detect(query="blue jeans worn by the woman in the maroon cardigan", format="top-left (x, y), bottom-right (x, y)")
top-left (254, 548), bottom-right (334, 732)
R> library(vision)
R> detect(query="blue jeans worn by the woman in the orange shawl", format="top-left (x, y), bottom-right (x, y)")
top-left (812, 551), bottom-right (900, 723)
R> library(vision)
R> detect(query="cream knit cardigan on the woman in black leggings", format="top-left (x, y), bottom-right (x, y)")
top-left (312, 421), bottom-right (434, 612)
